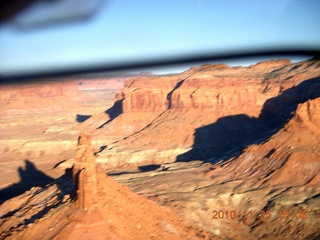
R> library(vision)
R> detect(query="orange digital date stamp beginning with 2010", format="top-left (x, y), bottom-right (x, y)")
top-left (212, 210), bottom-right (308, 219)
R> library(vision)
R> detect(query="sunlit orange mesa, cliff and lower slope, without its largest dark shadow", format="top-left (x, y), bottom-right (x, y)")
top-left (79, 60), bottom-right (320, 170)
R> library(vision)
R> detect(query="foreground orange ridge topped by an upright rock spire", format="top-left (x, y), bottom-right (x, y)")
top-left (0, 134), bottom-right (218, 239)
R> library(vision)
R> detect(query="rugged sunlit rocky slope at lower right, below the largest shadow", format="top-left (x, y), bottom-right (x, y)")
top-left (113, 98), bottom-right (320, 239)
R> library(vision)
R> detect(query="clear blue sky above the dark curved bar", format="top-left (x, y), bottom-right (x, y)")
top-left (0, 0), bottom-right (320, 74)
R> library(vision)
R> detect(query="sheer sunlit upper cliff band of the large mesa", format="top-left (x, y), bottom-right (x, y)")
top-left (118, 60), bottom-right (319, 116)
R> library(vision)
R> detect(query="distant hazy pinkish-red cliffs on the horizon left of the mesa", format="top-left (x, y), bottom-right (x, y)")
top-left (0, 76), bottom-right (125, 114)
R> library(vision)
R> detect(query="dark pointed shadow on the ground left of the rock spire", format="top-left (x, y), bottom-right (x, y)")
top-left (0, 160), bottom-right (54, 204)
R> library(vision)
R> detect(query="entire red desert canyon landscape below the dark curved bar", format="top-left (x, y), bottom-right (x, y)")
top-left (0, 59), bottom-right (320, 239)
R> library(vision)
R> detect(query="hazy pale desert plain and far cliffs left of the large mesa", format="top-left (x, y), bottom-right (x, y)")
top-left (0, 76), bottom-right (124, 188)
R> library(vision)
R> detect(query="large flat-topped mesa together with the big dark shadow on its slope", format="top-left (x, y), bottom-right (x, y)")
top-left (79, 60), bottom-right (320, 169)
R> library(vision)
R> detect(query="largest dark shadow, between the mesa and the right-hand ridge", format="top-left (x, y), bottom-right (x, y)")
top-left (176, 77), bottom-right (320, 163)
